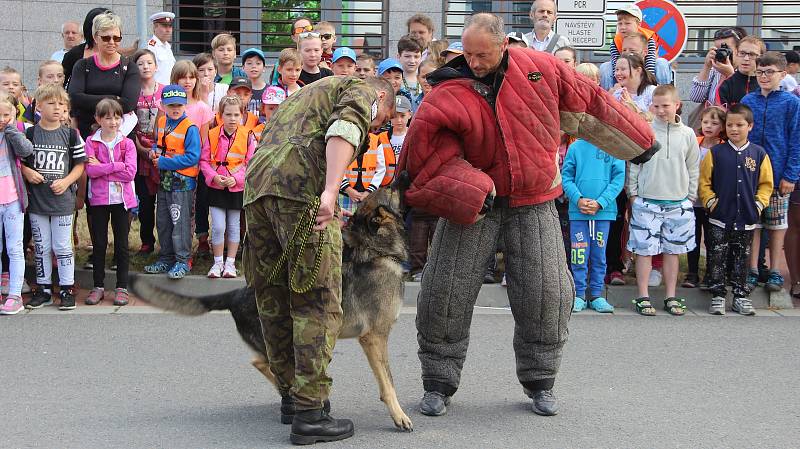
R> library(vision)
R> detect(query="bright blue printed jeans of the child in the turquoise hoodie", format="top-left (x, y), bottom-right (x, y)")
top-left (569, 220), bottom-right (611, 300)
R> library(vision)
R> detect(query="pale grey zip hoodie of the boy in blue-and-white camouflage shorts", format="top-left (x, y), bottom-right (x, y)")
top-left (625, 115), bottom-right (700, 201)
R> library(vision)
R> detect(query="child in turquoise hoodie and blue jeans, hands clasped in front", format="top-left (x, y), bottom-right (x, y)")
top-left (562, 140), bottom-right (625, 313)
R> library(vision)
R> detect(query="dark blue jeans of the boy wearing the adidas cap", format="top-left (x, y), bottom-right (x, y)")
top-left (156, 189), bottom-right (194, 265)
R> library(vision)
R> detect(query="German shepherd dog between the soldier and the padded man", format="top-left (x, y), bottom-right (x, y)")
top-left (130, 189), bottom-right (413, 431)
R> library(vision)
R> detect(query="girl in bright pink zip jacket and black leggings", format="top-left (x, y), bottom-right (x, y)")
top-left (85, 98), bottom-right (138, 306)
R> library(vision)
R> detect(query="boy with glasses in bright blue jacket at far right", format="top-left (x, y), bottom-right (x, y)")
top-left (742, 51), bottom-right (800, 292)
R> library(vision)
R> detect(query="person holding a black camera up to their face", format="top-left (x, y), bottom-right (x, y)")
top-left (689, 27), bottom-right (747, 105)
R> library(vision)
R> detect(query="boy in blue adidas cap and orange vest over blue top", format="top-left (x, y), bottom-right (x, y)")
top-left (144, 84), bottom-right (200, 279)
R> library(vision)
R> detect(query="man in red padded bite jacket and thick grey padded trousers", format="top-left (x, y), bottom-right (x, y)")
top-left (400, 13), bottom-right (658, 416)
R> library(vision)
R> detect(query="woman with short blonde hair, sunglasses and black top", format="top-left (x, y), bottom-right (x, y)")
top-left (68, 12), bottom-right (141, 138)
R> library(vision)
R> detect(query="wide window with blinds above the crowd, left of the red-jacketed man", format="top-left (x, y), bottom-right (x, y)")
top-left (175, 0), bottom-right (389, 57)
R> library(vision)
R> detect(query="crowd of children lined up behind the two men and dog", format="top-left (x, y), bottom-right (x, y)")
top-left (0, 6), bottom-right (800, 315)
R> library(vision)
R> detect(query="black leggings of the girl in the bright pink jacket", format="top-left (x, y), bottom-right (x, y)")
top-left (89, 204), bottom-right (129, 288)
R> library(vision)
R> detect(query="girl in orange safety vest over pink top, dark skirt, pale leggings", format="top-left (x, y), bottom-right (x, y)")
top-left (200, 96), bottom-right (256, 278)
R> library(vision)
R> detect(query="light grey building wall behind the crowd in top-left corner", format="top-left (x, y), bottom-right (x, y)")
top-left (0, 0), bottom-right (164, 90)
